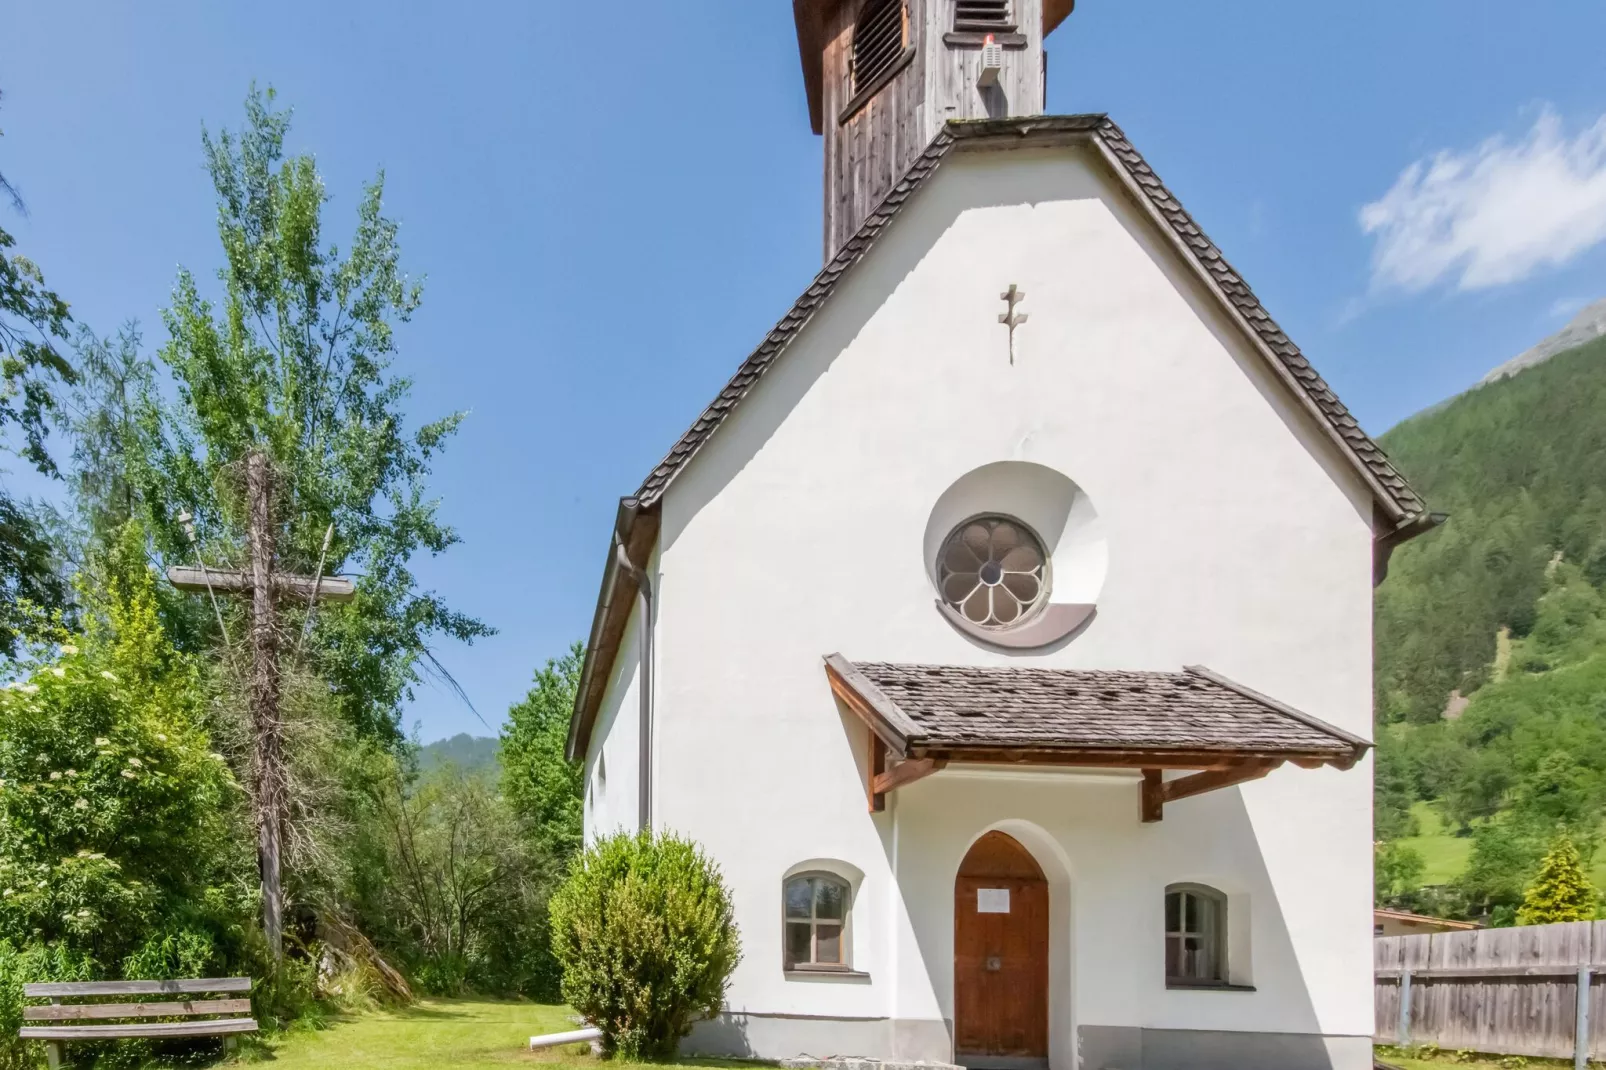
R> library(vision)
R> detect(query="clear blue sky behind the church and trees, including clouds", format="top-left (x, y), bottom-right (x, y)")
top-left (0, 0), bottom-right (1606, 739)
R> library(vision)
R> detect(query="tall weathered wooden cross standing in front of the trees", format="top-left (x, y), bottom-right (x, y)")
top-left (167, 450), bottom-right (357, 959)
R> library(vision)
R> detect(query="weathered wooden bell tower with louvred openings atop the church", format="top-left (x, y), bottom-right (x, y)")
top-left (792, 0), bottom-right (1074, 262)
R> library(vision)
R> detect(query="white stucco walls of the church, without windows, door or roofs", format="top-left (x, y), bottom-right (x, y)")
top-left (588, 149), bottom-right (1372, 1070)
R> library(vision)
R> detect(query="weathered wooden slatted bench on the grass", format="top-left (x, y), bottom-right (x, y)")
top-left (18, 977), bottom-right (257, 1068)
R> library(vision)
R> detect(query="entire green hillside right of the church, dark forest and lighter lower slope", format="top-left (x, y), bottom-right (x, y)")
top-left (1376, 339), bottom-right (1606, 917)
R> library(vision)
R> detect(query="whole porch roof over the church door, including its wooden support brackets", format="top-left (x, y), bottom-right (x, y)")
top-left (825, 654), bottom-right (1372, 821)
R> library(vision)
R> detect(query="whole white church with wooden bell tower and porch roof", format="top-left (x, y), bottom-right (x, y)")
top-left (569, 0), bottom-right (1436, 1070)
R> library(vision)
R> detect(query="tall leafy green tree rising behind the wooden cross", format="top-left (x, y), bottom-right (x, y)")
top-left (125, 88), bottom-right (490, 742)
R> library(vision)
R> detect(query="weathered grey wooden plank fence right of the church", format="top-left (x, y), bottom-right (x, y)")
top-left (1373, 921), bottom-right (1606, 1070)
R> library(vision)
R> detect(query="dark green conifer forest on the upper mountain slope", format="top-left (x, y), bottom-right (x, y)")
top-left (1376, 339), bottom-right (1606, 721)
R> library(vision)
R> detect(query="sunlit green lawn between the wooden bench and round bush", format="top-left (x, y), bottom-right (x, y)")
top-left (241, 999), bottom-right (753, 1070)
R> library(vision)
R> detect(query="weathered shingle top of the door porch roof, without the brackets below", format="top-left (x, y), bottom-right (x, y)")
top-left (825, 654), bottom-right (1370, 763)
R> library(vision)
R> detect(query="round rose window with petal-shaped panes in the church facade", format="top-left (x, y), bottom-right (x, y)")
top-left (936, 516), bottom-right (1049, 628)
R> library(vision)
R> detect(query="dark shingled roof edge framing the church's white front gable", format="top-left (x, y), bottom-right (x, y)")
top-left (636, 114), bottom-right (1426, 522)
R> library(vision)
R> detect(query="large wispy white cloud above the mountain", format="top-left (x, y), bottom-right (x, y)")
top-left (1360, 109), bottom-right (1606, 292)
